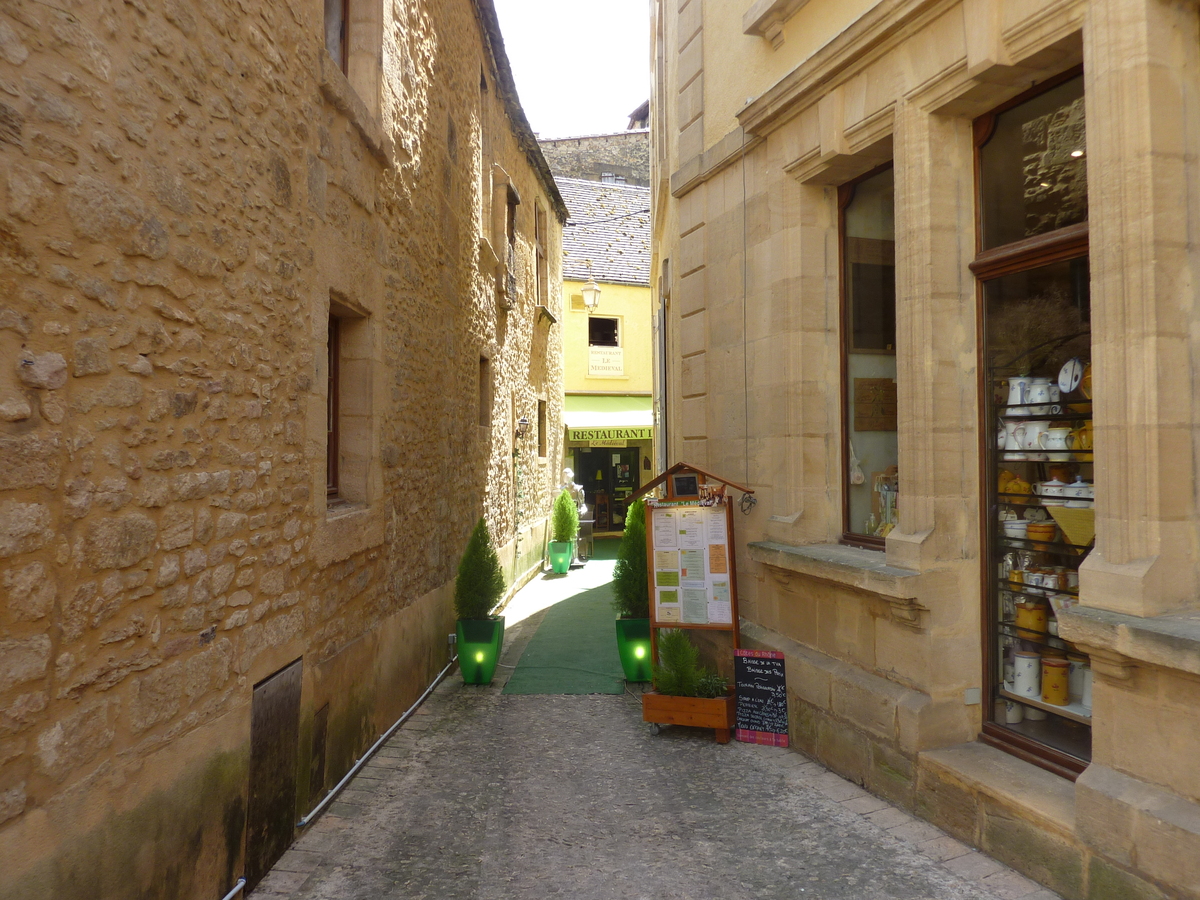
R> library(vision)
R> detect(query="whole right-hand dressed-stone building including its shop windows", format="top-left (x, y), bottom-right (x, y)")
top-left (650, 0), bottom-right (1200, 898)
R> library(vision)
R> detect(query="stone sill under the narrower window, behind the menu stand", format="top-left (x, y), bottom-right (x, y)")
top-left (748, 541), bottom-right (919, 602)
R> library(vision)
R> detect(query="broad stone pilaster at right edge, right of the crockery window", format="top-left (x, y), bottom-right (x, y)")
top-left (1080, 0), bottom-right (1200, 616)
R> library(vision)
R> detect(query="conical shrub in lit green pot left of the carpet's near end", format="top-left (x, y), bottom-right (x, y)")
top-left (454, 518), bottom-right (504, 684)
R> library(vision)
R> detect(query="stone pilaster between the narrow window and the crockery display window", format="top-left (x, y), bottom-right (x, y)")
top-left (887, 103), bottom-right (979, 570)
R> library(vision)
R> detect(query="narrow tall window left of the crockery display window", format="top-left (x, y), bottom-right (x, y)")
top-left (839, 164), bottom-right (899, 546)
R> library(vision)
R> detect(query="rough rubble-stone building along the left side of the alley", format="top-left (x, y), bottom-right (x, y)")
top-left (0, 0), bottom-right (566, 900)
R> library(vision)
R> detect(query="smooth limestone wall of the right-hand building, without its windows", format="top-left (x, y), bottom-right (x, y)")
top-left (652, 0), bottom-right (1200, 898)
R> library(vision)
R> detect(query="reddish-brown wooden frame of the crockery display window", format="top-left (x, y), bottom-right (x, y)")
top-left (967, 65), bottom-right (1090, 781)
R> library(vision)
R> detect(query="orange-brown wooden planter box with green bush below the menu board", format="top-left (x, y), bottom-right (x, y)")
top-left (642, 629), bottom-right (736, 744)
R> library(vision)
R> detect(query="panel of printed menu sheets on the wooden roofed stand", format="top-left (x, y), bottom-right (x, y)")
top-left (650, 504), bottom-right (733, 625)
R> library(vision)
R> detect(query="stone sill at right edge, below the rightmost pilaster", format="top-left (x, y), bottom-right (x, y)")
top-left (1058, 606), bottom-right (1200, 680)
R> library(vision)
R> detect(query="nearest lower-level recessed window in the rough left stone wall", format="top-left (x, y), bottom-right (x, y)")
top-left (325, 298), bottom-right (372, 504)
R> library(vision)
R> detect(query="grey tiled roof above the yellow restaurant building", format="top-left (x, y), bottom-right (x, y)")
top-left (557, 178), bottom-right (650, 286)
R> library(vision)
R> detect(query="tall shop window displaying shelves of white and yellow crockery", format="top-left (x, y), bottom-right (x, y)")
top-left (971, 70), bottom-right (1096, 776)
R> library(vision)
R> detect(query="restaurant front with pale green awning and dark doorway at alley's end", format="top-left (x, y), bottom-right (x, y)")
top-left (563, 394), bottom-right (654, 534)
